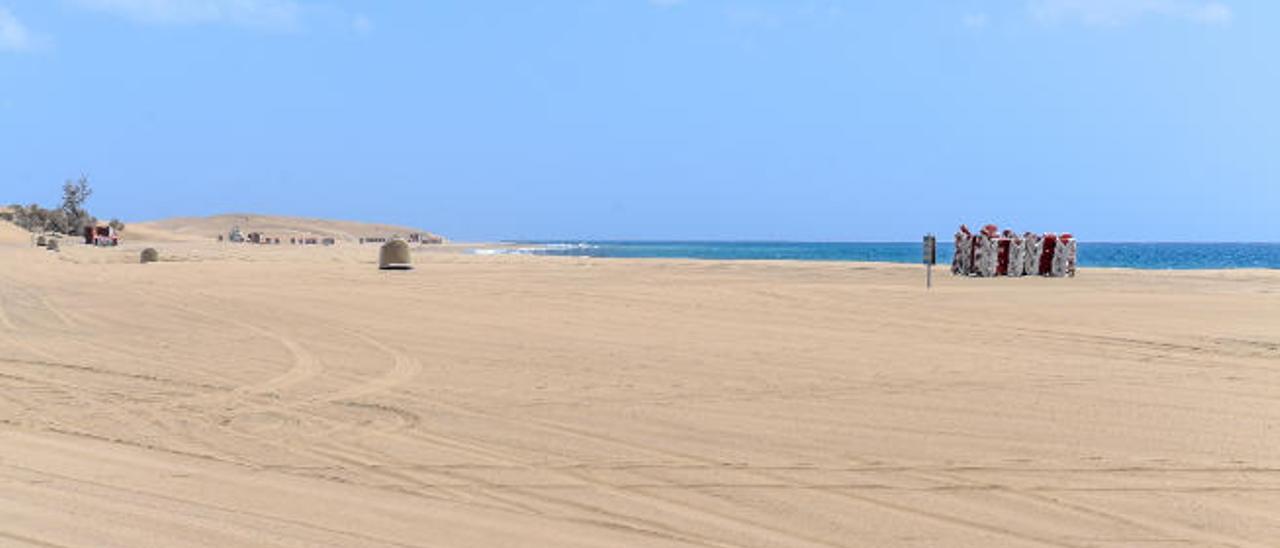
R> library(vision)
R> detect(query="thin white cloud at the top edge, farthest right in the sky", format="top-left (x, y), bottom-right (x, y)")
top-left (1029, 0), bottom-right (1234, 26)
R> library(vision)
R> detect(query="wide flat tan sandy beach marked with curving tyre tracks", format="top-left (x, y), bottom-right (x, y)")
top-left (0, 229), bottom-right (1280, 548)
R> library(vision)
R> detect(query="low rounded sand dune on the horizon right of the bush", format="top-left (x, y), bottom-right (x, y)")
top-left (125, 214), bottom-right (442, 242)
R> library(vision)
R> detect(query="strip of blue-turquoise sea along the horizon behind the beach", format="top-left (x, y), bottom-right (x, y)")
top-left (475, 241), bottom-right (1280, 270)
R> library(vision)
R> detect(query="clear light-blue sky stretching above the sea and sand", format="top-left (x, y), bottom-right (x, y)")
top-left (0, 0), bottom-right (1280, 241)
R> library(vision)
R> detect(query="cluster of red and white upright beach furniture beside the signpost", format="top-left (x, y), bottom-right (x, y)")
top-left (951, 224), bottom-right (1075, 278)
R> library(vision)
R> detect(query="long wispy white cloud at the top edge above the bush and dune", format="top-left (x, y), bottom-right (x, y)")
top-left (74, 0), bottom-right (302, 29)
